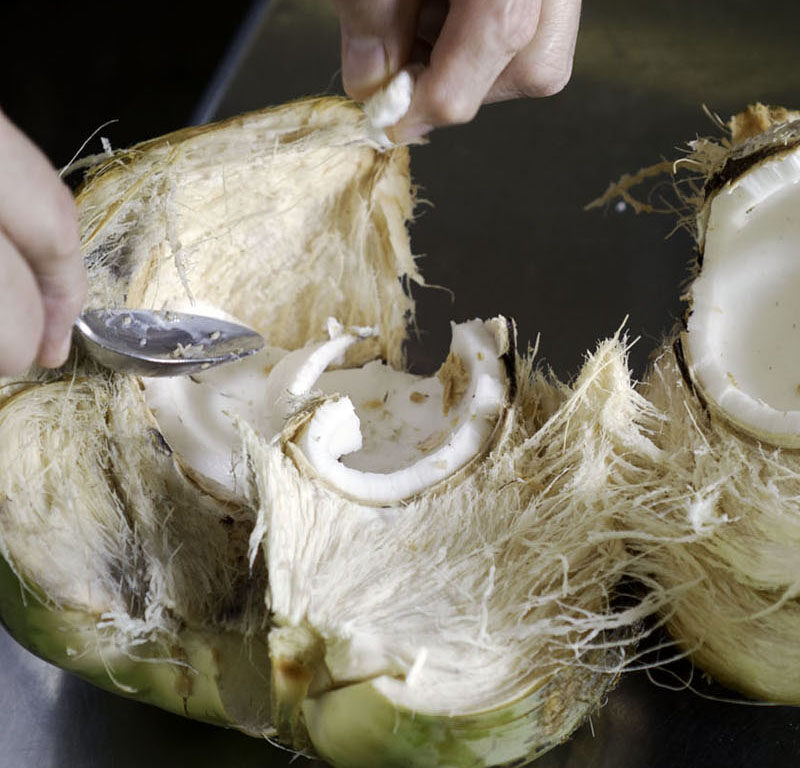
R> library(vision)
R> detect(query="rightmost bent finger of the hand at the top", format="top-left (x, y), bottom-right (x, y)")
top-left (484, 0), bottom-right (581, 103)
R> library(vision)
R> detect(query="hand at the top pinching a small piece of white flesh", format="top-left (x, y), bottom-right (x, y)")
top-left (335, 0), bottom-right (581, 142)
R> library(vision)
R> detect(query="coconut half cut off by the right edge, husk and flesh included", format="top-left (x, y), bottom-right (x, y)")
top-left (592, 105), bottom-right (800, 704)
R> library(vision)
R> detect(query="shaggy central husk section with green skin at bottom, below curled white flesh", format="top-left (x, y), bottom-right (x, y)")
top-left (246, 339), bottom-right (657, 767)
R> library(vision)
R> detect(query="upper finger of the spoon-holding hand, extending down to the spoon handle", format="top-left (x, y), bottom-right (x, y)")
top-left (0, 113), bottom-right (86, 367)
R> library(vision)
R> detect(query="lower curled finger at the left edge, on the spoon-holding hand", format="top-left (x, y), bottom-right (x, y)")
top-left (0, 232), bottom-right (44, 376)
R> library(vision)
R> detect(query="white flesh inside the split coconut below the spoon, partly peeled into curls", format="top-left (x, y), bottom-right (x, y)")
top-left (144, 319), bottom-right (509, 505)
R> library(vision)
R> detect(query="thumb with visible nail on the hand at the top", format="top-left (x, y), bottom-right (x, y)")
top-left (335, 0), bottom-right (421, 101)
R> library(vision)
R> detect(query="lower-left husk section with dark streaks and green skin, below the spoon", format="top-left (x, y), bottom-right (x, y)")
top-left (0, 376), bottom-right (271, 734)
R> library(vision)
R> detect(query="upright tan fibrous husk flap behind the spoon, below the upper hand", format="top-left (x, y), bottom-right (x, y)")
top-left (77, 98), bottom-right (421, 365)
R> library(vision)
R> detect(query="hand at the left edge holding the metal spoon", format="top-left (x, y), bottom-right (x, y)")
top-left (0, 112), bottom-right (86, 375)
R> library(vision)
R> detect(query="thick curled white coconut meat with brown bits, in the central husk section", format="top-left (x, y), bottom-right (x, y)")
top-left (297, 320), bottom-right (506, 505)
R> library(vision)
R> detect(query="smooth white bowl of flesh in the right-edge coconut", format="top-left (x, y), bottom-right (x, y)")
top-left (683, 149), bottom-right (800, 447)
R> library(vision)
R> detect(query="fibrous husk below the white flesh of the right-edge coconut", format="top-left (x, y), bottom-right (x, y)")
top-left (630, 347), bottom-right (800, 704)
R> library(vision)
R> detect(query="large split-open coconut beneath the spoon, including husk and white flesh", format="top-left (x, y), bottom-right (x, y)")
top-left (0, 94), bottom-right (658, 766)
